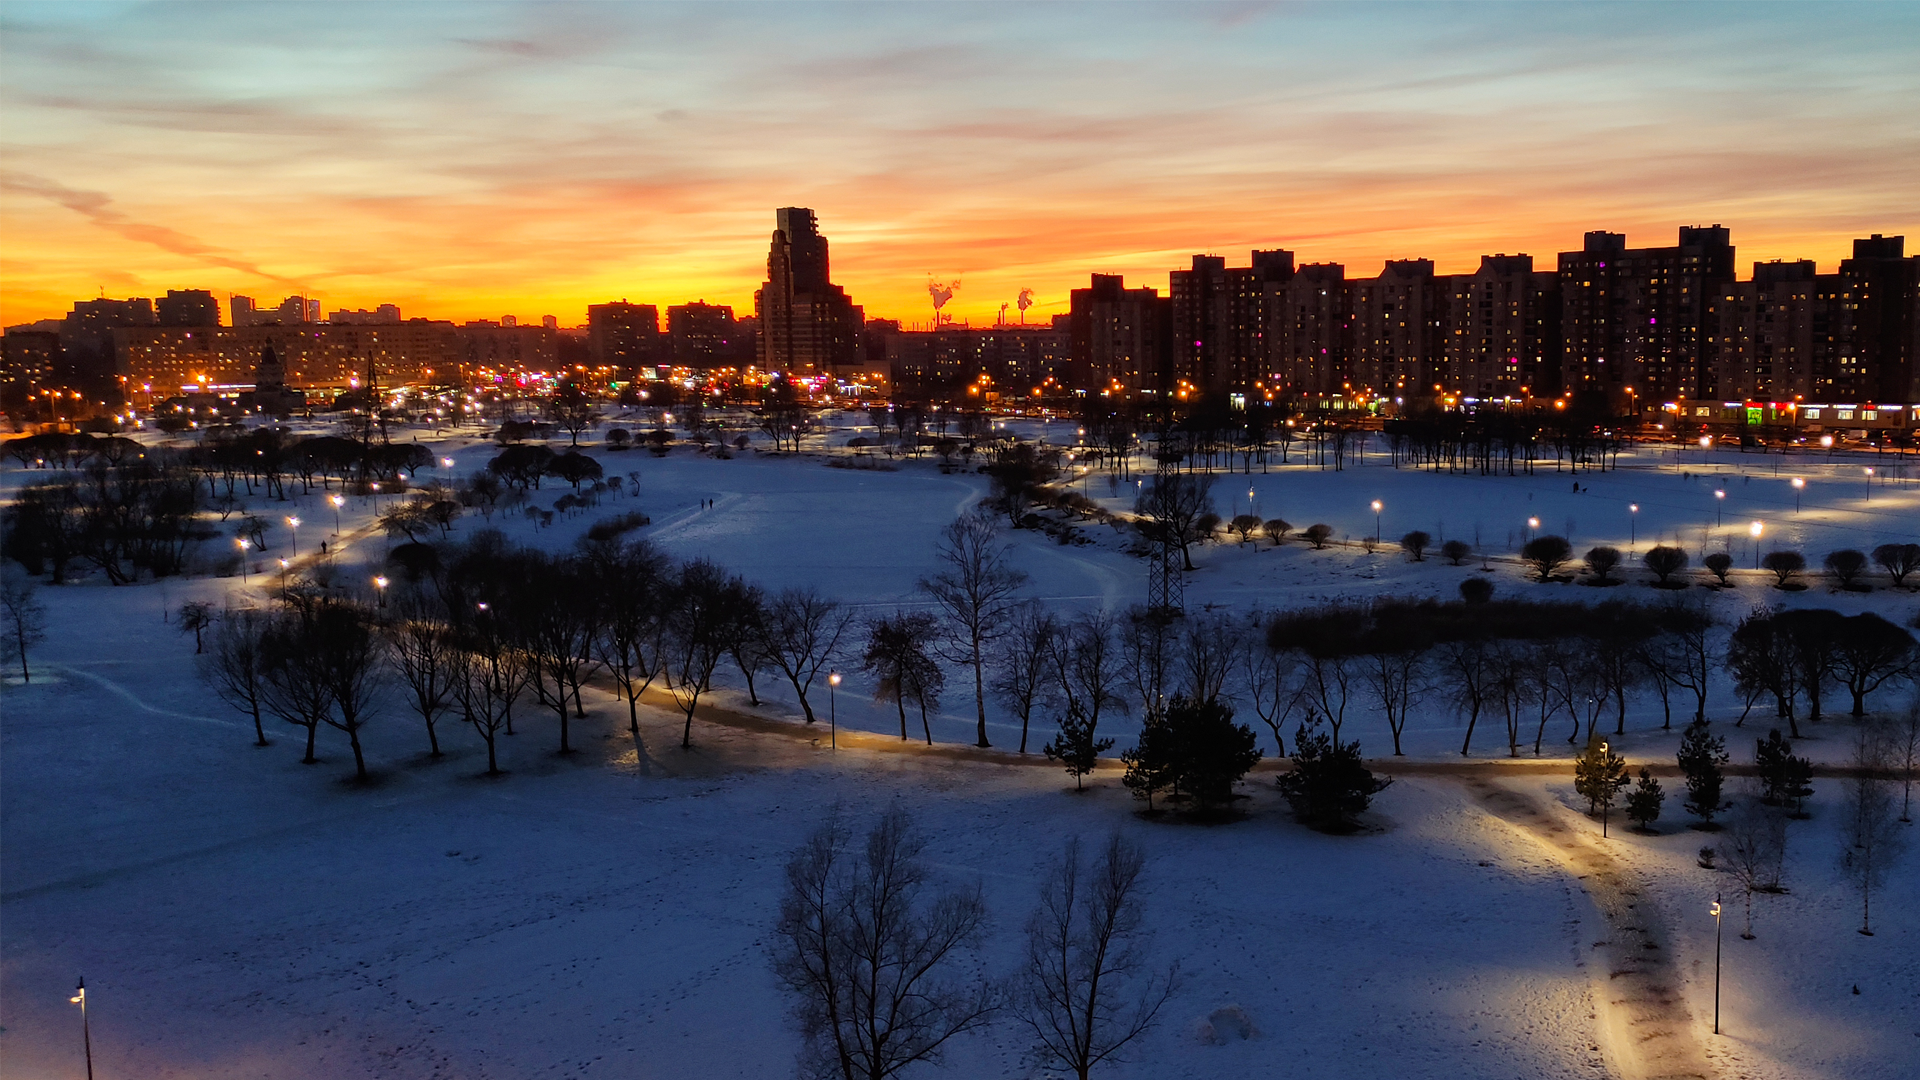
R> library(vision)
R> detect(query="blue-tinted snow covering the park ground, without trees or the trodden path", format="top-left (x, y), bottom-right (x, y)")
top-left (0, 425), bottom-right (1920, 1078)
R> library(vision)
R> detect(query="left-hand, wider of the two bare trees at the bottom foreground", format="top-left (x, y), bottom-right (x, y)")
top-left (774, 809), bottom-right (998, 1080)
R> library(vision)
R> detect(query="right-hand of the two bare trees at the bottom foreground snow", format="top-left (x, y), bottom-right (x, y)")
top-left (1014, 834), bottom-right (1179, 1080)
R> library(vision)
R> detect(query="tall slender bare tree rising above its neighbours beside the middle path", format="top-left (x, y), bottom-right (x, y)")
top-left (920, 509), bottom-right (1027, 746)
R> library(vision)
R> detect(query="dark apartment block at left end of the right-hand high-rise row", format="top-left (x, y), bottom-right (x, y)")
top-left (1068, 273), bottom-right (1175, 398)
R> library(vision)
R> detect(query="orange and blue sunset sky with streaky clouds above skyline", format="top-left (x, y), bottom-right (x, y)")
top-left (0, 2), bottom-right (1920, 325)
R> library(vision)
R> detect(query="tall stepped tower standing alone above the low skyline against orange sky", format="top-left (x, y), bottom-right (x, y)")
top-left (753, 206), bottom-right (864, 377)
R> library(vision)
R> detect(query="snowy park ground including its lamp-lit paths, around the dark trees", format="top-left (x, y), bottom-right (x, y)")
top-left (0, 417), bottom-right (1920, 1080)
